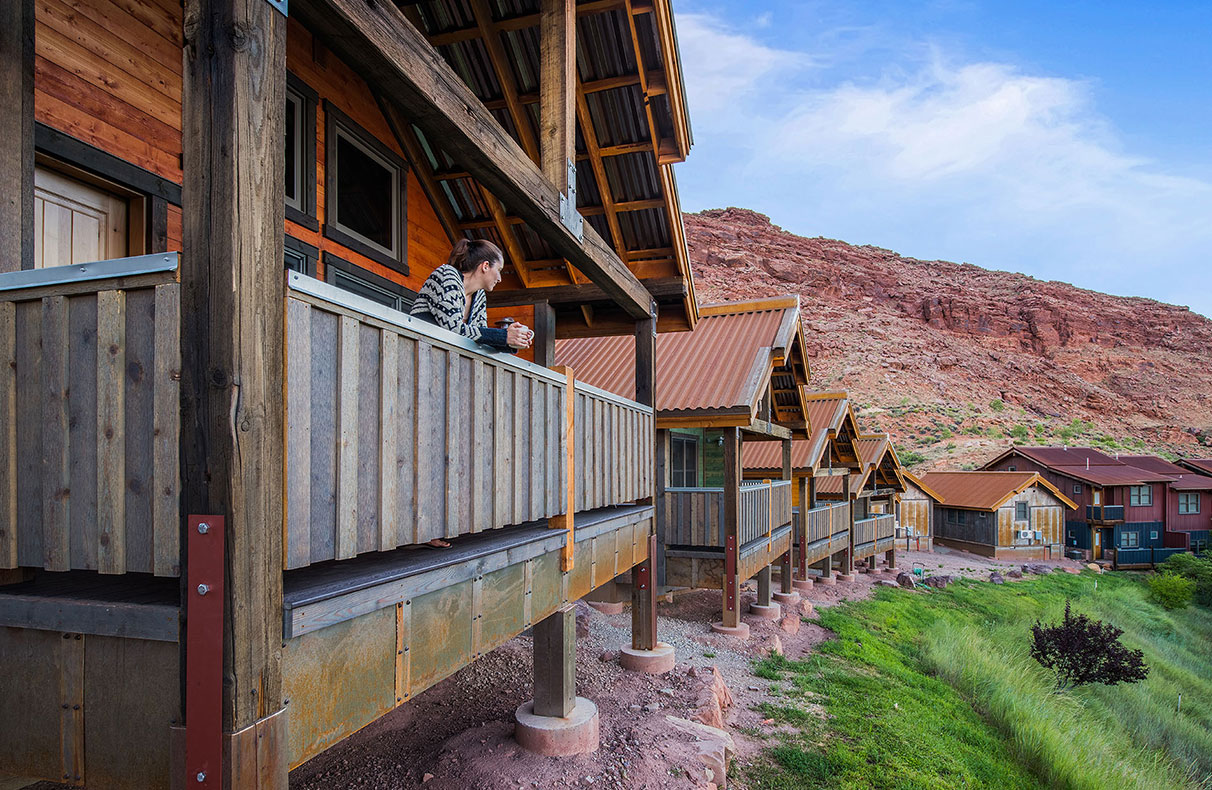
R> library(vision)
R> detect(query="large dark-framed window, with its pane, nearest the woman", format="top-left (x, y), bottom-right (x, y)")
top-left (324, 102), bottom-right (408, 274)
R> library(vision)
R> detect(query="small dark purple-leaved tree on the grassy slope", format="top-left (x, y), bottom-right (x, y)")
top-left (1031, 601), bottom-right (1149, 692)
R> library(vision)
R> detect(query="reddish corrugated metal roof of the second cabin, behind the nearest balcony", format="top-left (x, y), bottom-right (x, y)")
top-left (555, 300), bottom-right (799, 414)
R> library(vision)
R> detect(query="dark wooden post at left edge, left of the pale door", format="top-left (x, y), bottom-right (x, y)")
top-left (0, 0), bottom-right (34, 271)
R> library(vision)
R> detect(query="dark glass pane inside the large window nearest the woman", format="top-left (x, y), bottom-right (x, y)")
top-left (337, 130), bottom-right (396, 252)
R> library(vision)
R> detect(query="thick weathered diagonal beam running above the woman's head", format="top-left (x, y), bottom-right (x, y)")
top-left (291, 0), bottom-right (648, 319)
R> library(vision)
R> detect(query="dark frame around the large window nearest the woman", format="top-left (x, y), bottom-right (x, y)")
top-left (324, 99), bottom-right (408, 274)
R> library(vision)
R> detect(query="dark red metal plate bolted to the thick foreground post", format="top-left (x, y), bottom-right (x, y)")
top-left (184, 515), bottom-right (224, 790)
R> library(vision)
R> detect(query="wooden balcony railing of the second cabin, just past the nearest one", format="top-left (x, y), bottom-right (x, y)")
top-left (664, 480), bottom-right (791, 548)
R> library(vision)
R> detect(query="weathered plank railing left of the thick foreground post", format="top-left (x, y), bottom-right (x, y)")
top-left (0, 253), bottom-right (181, 576)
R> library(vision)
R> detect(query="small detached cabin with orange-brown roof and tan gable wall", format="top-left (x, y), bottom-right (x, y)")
top-left (921, 471), bottom-right (1077, 560)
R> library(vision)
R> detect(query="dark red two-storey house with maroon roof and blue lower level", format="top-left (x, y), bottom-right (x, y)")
top-left (982, 447), bottom-right (1192, 561)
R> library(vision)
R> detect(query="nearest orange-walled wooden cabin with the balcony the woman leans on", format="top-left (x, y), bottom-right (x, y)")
top-left (0, 0), bottom-right (698, 789)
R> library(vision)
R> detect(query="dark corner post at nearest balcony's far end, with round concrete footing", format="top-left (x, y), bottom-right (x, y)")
top-left (618, 312), bottom-right (675, 675)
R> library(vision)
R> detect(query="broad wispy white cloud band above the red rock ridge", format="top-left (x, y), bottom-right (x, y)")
top-left (680, 15), bottom-right (1212, 314)
